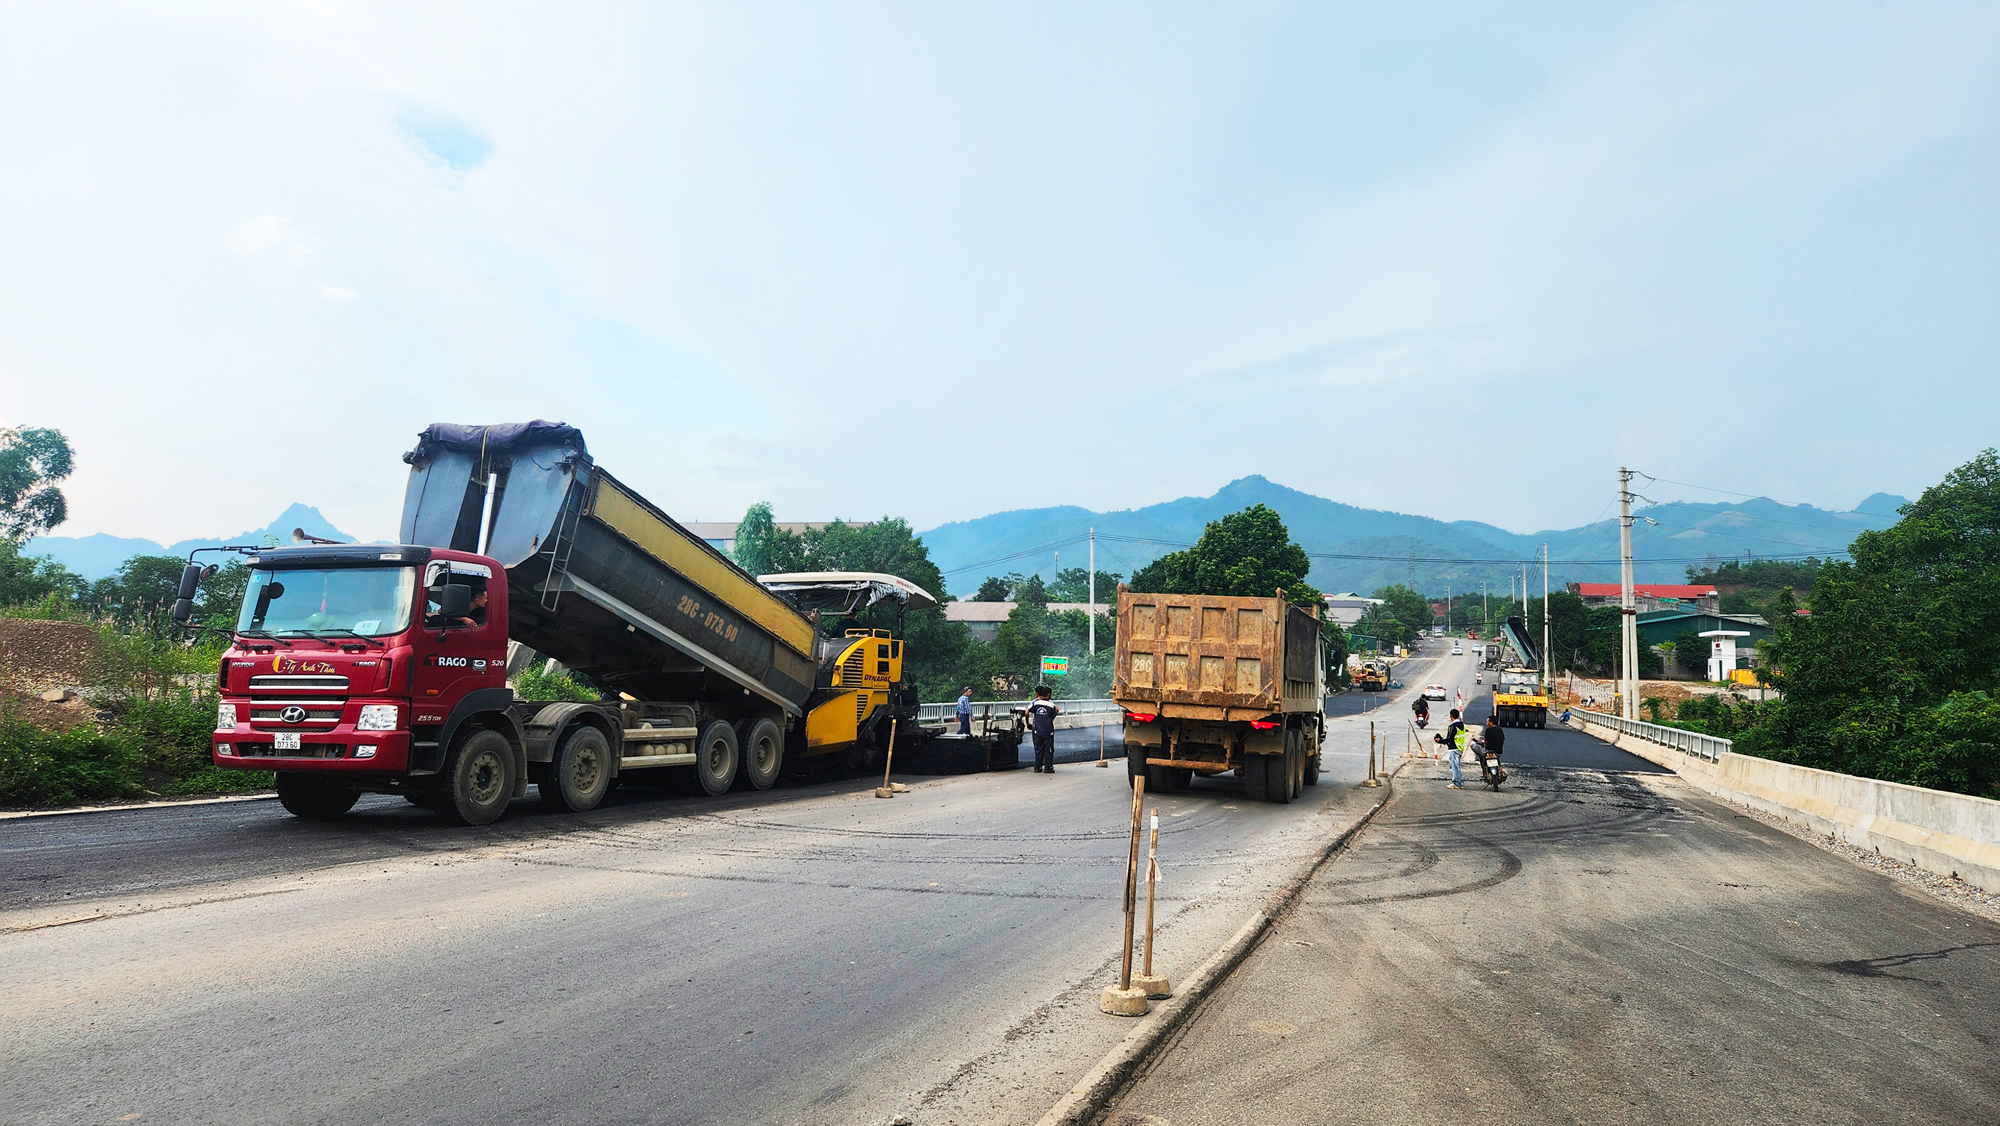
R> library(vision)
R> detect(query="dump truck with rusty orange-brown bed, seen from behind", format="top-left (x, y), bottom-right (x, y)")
top-left (1112, 586), bottom-right (1326, 802)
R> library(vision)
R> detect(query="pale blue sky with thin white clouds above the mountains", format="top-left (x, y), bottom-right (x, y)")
top-left (0, 2), bottom-right (2000, 540)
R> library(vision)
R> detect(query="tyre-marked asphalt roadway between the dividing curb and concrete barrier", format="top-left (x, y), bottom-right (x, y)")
top-left (1104, 744), bottom-right (2000, 1126)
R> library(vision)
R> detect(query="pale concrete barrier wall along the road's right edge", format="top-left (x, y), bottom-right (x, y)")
top-left (1584, 724), bottom-right (2000, 894)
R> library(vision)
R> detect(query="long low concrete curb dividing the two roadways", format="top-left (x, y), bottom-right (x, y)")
top-left (1036, 764), bottom-right (1402, 1126)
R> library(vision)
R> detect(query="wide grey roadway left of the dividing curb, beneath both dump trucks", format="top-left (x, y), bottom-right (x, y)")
top-left (0, 720), bottom-right (1380, 1126)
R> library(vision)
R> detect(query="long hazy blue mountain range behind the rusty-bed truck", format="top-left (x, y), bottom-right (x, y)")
top-left (924, 476), bottom-right (1904, 596)
